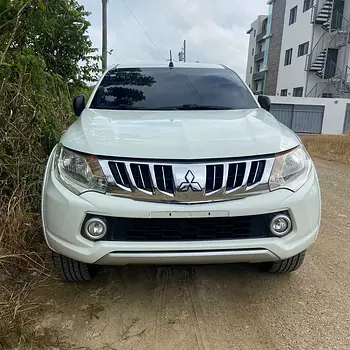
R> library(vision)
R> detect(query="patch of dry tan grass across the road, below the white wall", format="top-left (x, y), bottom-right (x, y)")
top-left (301, 131), bottom-right (350, 165)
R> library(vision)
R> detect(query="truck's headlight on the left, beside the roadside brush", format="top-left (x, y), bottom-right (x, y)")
top-left (54, 144), bottom-right (107, 195)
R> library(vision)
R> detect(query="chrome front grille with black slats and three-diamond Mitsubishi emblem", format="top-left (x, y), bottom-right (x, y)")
top-left (99, 157), bottom-right (274, 203)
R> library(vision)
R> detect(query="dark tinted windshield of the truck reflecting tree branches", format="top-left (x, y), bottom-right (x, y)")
top-left (90, 67), bottom-right (257, 110)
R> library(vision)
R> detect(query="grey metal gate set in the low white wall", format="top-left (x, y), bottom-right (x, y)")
top-left (271, 103), bottom-right (326, 134)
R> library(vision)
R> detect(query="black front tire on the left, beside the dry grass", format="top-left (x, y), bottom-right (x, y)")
top-left (52, 252), bottom-right (97, 282)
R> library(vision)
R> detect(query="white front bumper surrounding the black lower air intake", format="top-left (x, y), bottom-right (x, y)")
top-left (42, 154), bottom-right (320, 265)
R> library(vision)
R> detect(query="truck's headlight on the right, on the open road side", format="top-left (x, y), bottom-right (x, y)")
top-left (269, 146), bottom-right (312, 191)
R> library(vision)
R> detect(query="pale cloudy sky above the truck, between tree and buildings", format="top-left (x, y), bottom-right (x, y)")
top-left (78, 0), bottom-right (268, 77)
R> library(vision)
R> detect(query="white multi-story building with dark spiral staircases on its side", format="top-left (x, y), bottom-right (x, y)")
top-left (247, 0), bottom-right (350, 97)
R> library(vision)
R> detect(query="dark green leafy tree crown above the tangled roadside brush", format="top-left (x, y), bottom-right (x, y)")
top-left (0, 0), bottom-right (100, 83)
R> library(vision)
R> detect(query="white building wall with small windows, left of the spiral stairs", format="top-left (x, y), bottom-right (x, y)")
top-left (277, 0), bottom-right (313, 95)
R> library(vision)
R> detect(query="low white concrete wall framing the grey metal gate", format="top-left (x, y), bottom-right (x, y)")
top-left (270, 96), bottom-right (350, 134)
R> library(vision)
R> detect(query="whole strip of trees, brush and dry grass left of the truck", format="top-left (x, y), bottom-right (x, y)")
top-left (0, 0), bottom-right (99, 349)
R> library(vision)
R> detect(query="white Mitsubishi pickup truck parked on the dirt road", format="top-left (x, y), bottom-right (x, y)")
top-left (42, 62), bottom-right (320, 281)
